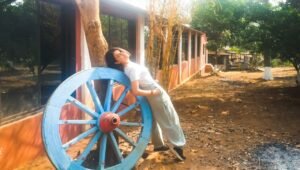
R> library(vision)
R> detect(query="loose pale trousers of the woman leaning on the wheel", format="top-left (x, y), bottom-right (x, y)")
top-left (142, 84), bottom-right (186, 148)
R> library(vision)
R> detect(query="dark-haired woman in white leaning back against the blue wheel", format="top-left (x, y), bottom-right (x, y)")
top-left (105, 48), bottom-right (186, 161)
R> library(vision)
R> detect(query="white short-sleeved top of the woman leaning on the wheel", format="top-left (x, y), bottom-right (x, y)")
top-left (124, 61), bottom-right (155, 87)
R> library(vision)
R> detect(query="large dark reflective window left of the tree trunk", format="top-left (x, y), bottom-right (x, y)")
top-left (0, 0), bottom-right (75, 125)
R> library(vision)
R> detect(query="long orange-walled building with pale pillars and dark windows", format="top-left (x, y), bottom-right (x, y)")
top-left (0, 0), bottom-right (207, 169)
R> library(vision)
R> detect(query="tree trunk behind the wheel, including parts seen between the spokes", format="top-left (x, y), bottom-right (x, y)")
top-left (75, 0), bottom-right (117, 165)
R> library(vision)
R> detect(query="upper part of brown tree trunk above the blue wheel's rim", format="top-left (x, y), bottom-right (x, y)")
top-left (76, 0), bottom-right (108, 67)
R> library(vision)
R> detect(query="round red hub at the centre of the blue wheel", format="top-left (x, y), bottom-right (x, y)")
top-left (99, 112), bottom-right (120, 133)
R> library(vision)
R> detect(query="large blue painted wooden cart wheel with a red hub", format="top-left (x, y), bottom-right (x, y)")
top-left (42, 68), bottom-right (152, 170)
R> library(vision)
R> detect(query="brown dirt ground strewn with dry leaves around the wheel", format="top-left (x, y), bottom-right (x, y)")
top-left (19, 68), bottom-right (300, 170)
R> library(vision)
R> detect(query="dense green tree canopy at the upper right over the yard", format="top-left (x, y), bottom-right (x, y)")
top-left (191, 0), bottom-right (300, 79)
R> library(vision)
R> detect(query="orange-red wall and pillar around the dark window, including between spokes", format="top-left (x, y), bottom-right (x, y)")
top-left (0, 2), bottom-right (81, 170)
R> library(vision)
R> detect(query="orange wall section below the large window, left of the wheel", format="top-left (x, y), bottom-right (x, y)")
top-left (0, 113), bottom-right (44, 170)
